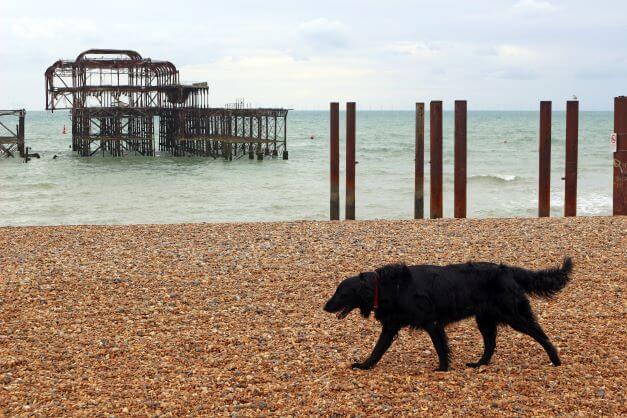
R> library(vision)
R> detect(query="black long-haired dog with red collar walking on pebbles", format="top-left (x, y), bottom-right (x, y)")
top-left (324, 258), bottom-right (573, 371)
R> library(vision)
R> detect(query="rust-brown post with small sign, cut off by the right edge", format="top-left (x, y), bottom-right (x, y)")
top-left (612, 96), bottom-right (627, 215)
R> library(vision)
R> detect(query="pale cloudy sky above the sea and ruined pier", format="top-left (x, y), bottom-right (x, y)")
top-left (0, 0), bottom-right (627, 110)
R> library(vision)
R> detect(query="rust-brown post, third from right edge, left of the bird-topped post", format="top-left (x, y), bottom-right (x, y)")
top-left (538, 101), bottom-right (551, 217)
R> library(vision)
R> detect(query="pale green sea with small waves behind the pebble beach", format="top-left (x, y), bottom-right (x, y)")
top-left (0, 111), bottom-right (613, 226)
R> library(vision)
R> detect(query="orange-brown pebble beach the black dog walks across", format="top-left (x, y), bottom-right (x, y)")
top-left (0, 217), bottom-right (627, 417)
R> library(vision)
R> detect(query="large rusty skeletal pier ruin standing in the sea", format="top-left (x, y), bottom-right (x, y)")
top-left (45, 49), bottom-right (288, 159)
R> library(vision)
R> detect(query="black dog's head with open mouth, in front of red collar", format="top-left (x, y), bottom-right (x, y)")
top-left (324, 273), bottom-right (374, 319)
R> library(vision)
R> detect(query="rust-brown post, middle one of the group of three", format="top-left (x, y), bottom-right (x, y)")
top-left (429, 101), bottom-right (442, 219)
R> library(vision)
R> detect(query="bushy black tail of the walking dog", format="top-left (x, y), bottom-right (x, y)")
top-left (514, 257), bottom-right (573, 299)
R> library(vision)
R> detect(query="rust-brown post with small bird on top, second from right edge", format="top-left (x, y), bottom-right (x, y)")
top-left (564, 100), bottom-right (579, 216)
